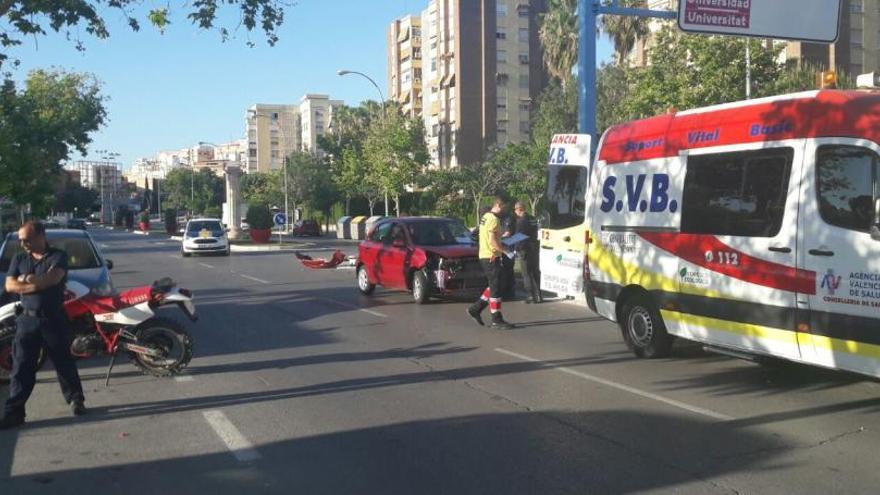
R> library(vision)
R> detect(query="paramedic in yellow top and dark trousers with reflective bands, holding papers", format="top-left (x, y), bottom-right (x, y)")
top-left (467, 196), bottom-right (513, 329)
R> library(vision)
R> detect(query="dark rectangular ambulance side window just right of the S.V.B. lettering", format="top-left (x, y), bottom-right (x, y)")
top-left (681, 148), bottom-right (794, 237)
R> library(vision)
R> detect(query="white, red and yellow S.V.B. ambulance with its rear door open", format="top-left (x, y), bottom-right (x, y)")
top-left (540, 90), bottom-right (880, 377)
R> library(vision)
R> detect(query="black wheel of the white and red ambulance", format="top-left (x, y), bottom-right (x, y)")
top-left (621, 295), bottom-right (672, 359)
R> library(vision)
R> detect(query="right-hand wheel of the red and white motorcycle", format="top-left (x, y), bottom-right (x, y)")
top-left (130, 317), bottom-right (192, 376)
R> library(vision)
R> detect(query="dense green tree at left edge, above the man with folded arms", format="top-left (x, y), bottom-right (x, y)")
top-left (0, 70), bottom-right (106, 215)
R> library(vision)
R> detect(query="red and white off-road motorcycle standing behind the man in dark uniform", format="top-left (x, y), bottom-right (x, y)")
top-left (0, 278), bottom-right (198, 385)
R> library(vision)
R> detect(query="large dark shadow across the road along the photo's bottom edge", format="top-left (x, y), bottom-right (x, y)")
top-left (0, 410), bottom-right (793, 495)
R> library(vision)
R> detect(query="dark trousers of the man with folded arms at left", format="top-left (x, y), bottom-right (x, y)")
top-left (5, 316), bottom-right (83, 416)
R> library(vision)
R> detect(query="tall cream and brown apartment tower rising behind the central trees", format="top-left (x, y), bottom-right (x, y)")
top-left (388, 0), bottom-right (548, 168)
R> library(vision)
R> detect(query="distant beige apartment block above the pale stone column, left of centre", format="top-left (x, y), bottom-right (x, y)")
top-left (245, 103), bottom-right (302, 172)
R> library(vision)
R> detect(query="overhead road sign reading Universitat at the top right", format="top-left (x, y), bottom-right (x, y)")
top-left (678, 0), bottom-right (843, 43)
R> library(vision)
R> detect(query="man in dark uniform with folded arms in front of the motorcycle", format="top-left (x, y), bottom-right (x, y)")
top-left (0, 222), bottom-right (86, 429)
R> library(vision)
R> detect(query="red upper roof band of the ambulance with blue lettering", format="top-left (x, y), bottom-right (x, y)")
top-left (599, 90), bottom-right (880, 163)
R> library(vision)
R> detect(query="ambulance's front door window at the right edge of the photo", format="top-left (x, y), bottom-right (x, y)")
top-left (816, 145), bottom-right (880, 232)
